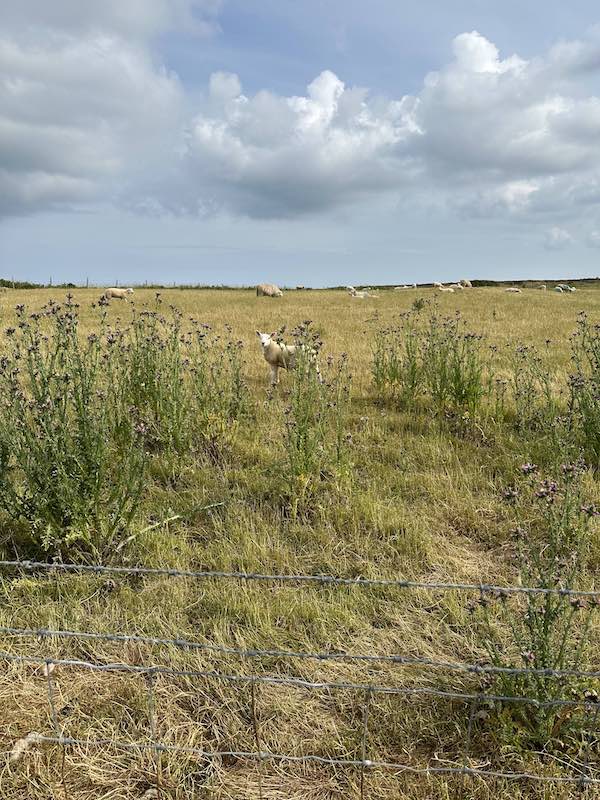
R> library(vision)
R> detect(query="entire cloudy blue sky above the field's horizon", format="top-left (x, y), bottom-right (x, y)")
top-left (0, 0), bottom-right (600, 286)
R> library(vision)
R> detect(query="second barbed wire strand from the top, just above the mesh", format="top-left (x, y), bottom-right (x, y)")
top-left (0, 625), bottom-right (600, 679)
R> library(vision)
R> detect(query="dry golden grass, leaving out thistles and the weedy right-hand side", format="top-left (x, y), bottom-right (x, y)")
top-left (0, 288), bottom-right (600, 800)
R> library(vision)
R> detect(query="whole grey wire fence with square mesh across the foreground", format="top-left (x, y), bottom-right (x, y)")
top-left (0, 560), bottom-right (600, 800)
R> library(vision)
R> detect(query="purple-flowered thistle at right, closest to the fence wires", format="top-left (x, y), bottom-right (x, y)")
top-left (472, 460), bottom-right (600, 746)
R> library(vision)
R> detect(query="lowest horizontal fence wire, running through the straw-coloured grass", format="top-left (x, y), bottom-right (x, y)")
top-left (30, 735), bottom-right (600, 785)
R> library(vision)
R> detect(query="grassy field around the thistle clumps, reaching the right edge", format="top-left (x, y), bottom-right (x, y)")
top-left (0, 288), bottom-right (600, 800)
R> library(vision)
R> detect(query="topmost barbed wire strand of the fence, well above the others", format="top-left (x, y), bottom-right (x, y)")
top-left (0, 560), bottom-right (600, 605)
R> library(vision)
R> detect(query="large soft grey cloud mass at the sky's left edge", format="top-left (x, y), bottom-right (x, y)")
top-left (0, 22), bottom-right (183, 215)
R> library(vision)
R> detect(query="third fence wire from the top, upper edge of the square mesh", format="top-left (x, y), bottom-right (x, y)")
top-left (0, 652), bottom-right (600, 710)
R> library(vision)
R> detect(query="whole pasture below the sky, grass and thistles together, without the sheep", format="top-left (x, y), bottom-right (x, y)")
top-left (0, 288), bottom-right (600, 800)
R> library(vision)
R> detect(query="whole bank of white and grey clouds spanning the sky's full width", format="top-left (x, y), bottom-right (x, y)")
top-left (0, 21), bottom-right (600, 234)
